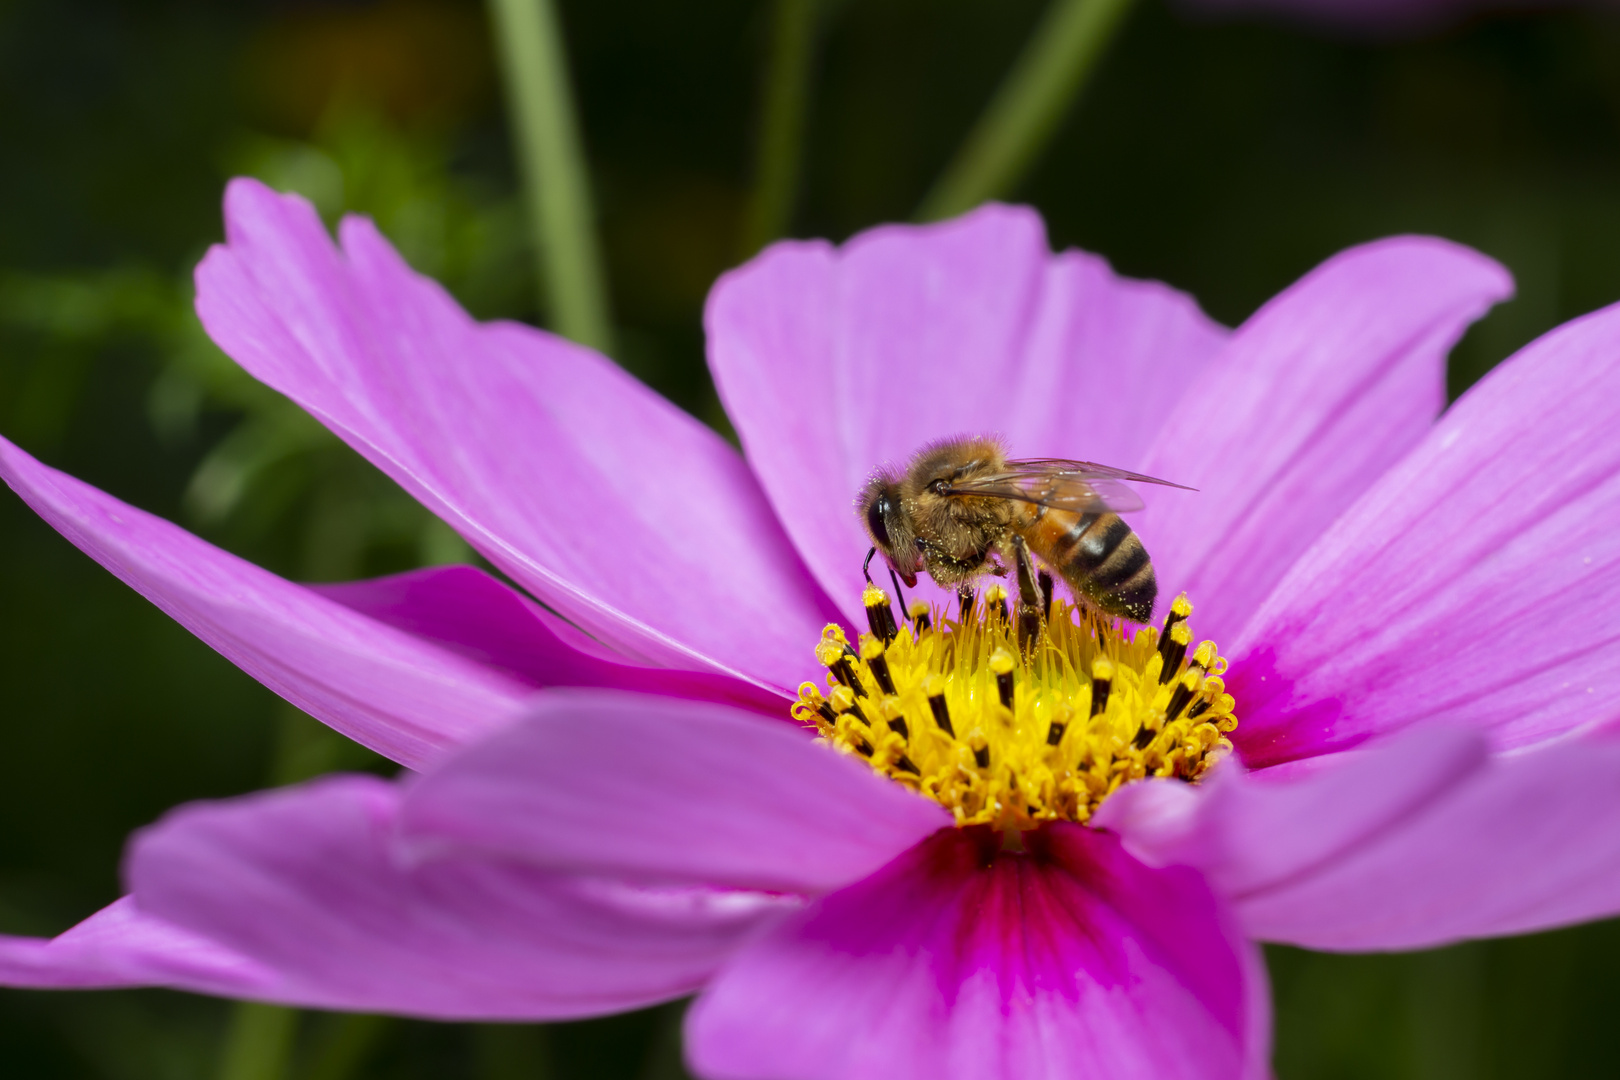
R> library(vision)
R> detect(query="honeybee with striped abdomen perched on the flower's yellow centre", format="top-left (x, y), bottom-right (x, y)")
top-left (857, 439), bottom-right (1192, 622)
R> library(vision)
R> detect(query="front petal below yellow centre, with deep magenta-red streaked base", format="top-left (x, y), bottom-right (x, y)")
top-left (687, 824), bottom-right (1270, 1080)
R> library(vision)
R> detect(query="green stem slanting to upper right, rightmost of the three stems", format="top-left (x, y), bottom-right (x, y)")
top-left (917, 0), bottom-right (1131, 222)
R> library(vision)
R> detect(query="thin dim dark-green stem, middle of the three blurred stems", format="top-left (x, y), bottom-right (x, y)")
top-left (740, 0), bottom-right (818, 259)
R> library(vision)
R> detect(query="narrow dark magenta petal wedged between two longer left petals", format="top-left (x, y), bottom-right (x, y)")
top-left (309, 567), bottom-right (791, 721)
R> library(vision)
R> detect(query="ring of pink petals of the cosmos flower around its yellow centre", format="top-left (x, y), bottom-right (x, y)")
top-left (0, 181), bottom-right (1620, 1080)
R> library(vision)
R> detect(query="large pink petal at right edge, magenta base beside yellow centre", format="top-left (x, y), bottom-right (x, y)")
top-left (1228, 297), bottom-right (1620, 766)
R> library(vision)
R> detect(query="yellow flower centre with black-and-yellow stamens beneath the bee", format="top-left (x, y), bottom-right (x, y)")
top-left (792, 586), bottom-right (1238, 836)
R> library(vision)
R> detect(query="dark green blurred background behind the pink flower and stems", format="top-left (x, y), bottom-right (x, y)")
top-left (0, 0), bottom-right (1620, 1080)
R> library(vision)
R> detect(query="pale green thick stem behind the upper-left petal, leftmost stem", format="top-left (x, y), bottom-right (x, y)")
top-left (489, 0), bottom-right (612, 353)
